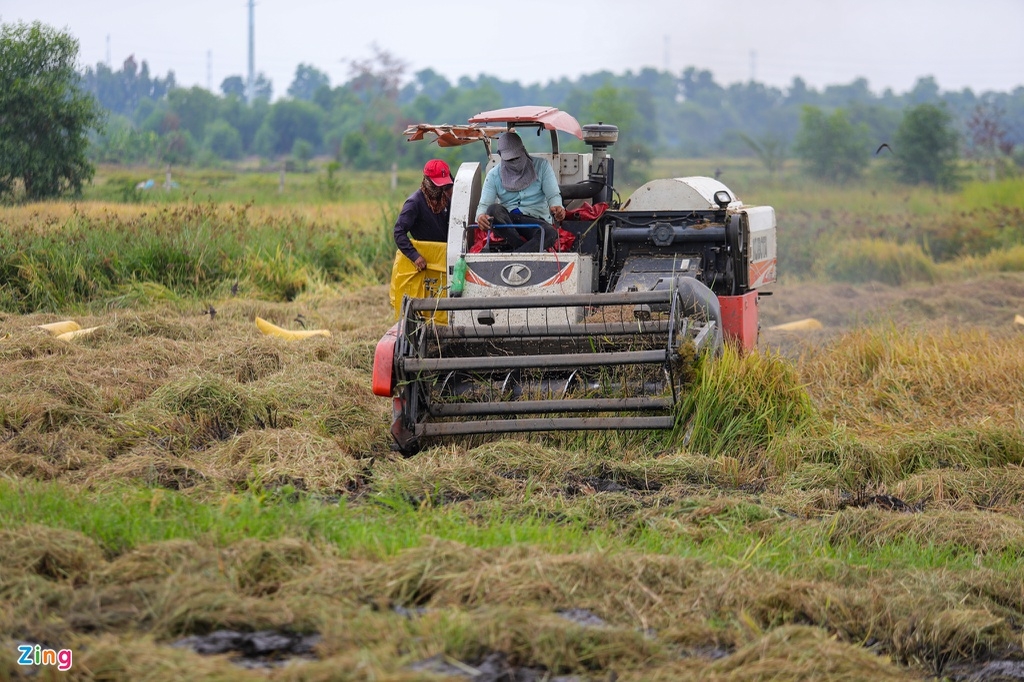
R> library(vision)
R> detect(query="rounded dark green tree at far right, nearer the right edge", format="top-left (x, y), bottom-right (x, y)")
top-left (893, 104), bottom-right (961, 189)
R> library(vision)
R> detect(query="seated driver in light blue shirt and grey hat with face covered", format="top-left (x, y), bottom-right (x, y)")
top-left (476, 132), bottom-right (565, 253)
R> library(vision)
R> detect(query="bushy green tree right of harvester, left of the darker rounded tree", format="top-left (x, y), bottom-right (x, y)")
top-left (794, 105), bottom-right (871, 183)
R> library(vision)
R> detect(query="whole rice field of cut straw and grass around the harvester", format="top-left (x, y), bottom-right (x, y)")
top-left (0, 173), bottom-right (1024, 681)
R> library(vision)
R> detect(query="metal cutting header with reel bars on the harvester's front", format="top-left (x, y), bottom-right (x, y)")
top-left (392, 278), bottom-right (722, 456)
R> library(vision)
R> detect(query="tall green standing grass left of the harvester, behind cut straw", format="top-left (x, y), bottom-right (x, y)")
top-left (0, 199), bottom-right (394, 312)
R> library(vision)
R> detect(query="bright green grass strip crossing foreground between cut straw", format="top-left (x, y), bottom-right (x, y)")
top-left (0, 480), bottom-right (1020, 578)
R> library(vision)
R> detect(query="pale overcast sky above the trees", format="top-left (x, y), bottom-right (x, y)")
top-left (0, 0), bottom-right (1024, 98)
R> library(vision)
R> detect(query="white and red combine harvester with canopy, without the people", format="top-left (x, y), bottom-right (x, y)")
top-left (373, 106), bottom-right (775, 456)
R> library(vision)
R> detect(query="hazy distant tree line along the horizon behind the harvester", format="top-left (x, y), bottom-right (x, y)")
top-left (84, 42), bottom-right (1024, 169)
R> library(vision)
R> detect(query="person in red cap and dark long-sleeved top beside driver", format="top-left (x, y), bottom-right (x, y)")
top-left (394, 159), bottom-right (452, 272)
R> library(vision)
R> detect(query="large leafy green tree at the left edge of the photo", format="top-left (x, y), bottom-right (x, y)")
top-left (0, 22), bottom-right (100, 200)
